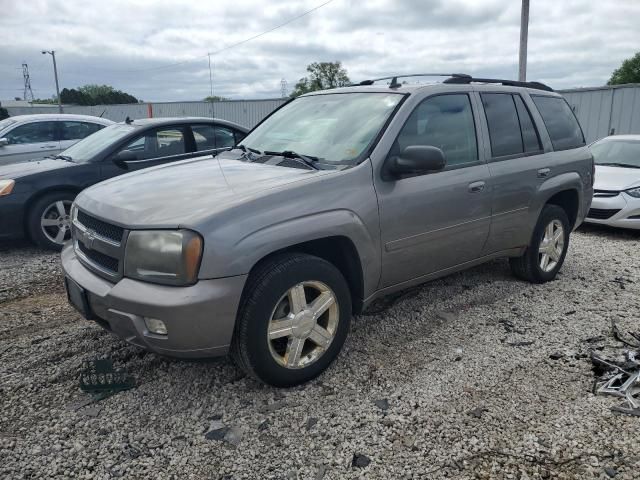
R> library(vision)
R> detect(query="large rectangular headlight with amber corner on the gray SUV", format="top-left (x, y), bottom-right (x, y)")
top-left (124, 230), bottom-right (203, 286)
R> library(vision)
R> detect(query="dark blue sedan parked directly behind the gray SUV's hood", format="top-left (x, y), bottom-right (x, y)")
top-left (0, 118), bottom-right (247, 249)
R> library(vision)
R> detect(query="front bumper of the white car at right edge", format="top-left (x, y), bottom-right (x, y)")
top-left (584, 192), bottom-right (640, 229)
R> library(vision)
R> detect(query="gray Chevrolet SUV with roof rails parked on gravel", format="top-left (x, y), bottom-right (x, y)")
top-left (62, 74), bottom-right (594, 386)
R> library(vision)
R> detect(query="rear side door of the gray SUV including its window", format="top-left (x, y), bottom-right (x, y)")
top-left (477, 91), bottom-right (552, 254)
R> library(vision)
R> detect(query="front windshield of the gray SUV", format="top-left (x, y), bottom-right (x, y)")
top-left (241, 92), bottom-right (402, 164)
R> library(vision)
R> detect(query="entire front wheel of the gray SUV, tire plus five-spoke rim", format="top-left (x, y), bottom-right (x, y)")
top-left (231, 253), bottom-right (351, 387)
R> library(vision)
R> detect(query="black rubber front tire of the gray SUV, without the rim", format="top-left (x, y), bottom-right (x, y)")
top-left (240, 256), bottom-right (351, 387)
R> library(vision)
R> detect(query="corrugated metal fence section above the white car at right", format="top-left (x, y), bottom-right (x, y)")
top-left (560, 84), bottom-right (640, 142)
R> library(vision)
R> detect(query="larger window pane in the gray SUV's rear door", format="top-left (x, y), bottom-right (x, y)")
top-left (480, 93), bottom-right (524, 157)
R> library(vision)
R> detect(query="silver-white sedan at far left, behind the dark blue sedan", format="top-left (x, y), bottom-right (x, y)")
top-left (0, 113), bottom-right (114, 165)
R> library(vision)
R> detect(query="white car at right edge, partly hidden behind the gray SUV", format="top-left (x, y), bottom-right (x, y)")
top-left (585, 135), bottom-right (640, 229)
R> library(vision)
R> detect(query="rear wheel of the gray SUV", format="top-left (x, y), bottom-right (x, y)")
top-left (509, 205), bottom-right (571, 283)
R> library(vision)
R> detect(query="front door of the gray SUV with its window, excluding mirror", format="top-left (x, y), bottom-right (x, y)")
top-left (376, 93), bottom-right (491, 288)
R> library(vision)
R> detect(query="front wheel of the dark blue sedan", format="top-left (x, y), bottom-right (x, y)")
top-left (27, 191), bottom-right (75, 251)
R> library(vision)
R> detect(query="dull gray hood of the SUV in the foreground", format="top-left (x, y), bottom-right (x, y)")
top-left (76, 156), bottom-right (334, 228)
